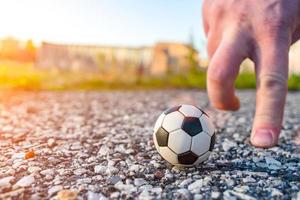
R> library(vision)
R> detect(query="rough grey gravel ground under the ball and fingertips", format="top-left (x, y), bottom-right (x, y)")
top-left (0, 90), bottom-right (300, 200)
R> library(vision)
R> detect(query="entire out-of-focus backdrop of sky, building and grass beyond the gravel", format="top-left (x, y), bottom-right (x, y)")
top-left (0, 0), bottom-right (300, 90)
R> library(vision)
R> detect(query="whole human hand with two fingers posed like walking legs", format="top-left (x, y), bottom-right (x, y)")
top-left (203, 0), bottom-right (300, 148)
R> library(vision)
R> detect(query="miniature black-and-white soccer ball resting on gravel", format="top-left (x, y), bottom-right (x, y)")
top-left (153, 105), bottom-right (216, 167)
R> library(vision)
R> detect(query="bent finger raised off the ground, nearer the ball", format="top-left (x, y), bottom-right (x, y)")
top-left (207, 29), bottom-right (247, 111)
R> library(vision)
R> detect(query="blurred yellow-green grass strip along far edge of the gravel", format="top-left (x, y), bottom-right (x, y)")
top-left (0, 63), bottom-right (300, 90)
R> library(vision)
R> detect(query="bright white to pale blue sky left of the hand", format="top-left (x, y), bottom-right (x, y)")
top-left (0, 0), bottom-right (205, 54)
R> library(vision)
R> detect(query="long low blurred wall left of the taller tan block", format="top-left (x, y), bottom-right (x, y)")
top-left (37, 43), bottom-right (152, 71)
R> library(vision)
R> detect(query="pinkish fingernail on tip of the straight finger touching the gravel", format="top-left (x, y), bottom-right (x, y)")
top-left (252, 129), bottom-right (274, 147)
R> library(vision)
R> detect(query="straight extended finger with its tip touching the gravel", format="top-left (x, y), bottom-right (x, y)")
top-left (251, 32), bottom-right (290, 148)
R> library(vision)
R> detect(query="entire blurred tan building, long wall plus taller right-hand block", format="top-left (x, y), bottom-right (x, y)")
top-left (37, 43), bottom-right (198, 75)
